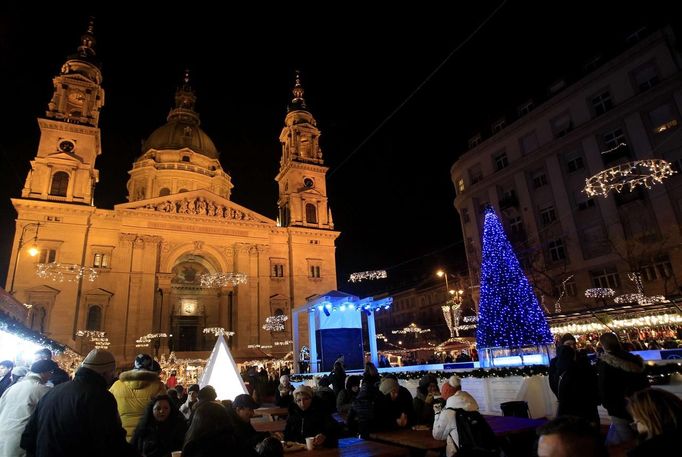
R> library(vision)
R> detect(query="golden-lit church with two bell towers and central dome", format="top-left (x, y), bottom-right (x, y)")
top-left (6, 26), bottom-right (339, 363)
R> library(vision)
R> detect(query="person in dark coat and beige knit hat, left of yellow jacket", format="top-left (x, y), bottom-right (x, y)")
top-left (21, 349), bottom-right (138, 457)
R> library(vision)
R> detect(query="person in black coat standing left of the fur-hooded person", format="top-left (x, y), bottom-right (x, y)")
top-left (556, 346), bottom-right (599, 428)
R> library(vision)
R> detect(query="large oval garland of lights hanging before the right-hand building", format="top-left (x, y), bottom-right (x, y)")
top-left (583, 159), bottom-right (677, 198)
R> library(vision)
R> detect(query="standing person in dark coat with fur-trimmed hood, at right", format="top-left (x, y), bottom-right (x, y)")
top-left (597, 333), bottom-right (649, 446)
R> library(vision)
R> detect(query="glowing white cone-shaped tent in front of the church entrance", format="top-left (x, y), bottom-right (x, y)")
top-left (199, 335), bottom-right (248, 400)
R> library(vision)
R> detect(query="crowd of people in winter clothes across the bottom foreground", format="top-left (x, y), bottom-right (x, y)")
top-left (0, 333), bottom-right (682, 457)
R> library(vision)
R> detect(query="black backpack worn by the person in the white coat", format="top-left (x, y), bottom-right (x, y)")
top-left (447, 408), bottom-right (500, 457)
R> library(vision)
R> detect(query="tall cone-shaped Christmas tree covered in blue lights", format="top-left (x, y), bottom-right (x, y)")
top-left (476, 207), bottom-right (553, 348)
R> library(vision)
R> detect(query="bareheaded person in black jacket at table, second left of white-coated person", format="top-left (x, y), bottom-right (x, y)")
top-left (374, 377), bottom-right (416, 430)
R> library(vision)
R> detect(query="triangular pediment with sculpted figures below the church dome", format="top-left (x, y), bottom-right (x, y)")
top-left (114, 189), bottom-right (277, 225)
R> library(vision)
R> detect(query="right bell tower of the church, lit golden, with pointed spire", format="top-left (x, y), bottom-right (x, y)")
top-left (275, 72), bottom-right (334, 230)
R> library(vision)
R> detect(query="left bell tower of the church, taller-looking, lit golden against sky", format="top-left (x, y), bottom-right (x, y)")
top-left (21, 18), bottom-right (104, 205)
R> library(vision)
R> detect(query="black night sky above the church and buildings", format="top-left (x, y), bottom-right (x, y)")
top-left (0, 1), bottom-right (670, 293)
